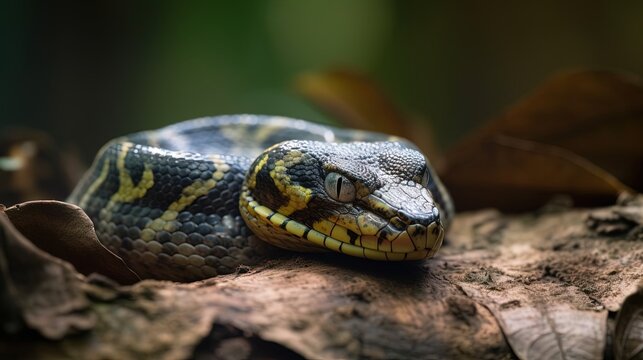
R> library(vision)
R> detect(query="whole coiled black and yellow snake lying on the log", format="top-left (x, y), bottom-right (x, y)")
top-left (67, 115), bottom-right (454, 281)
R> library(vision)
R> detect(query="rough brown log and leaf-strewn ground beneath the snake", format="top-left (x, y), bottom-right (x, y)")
top-left (0, 197), bottom-right (643, 359)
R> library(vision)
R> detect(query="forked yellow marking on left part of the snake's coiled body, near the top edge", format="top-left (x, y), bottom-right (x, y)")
top-left (110, 142), bottom-right (154, 205)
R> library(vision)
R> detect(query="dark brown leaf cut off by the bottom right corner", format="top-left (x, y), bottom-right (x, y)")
top-left (614, 283), bottom-right (643, 360)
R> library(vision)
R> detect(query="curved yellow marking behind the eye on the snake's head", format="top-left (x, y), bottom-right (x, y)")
top-left (270, 150), bottom-right (312, 216)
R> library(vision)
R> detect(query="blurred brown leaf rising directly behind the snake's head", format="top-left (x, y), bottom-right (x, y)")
top-left (295, 70), bottom-right (439, 162)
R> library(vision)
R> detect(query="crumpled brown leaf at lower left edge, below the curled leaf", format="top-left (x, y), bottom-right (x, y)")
top-left (0, 208), bottom-right (96, 339)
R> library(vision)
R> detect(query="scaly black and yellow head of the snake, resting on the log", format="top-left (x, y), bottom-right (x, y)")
top-left (240, 140), bottom-right (450, 260)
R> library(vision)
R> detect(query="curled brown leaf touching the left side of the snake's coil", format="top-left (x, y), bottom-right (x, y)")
top-left (6, 200), bottom-right (140, 284)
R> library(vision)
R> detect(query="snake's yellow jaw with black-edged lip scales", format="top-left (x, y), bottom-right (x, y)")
top-left (240, 188), bottom-right (444, 261)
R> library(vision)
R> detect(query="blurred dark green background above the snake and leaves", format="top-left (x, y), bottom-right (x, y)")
top-left (0, 0), bottom-right (643, 160)
